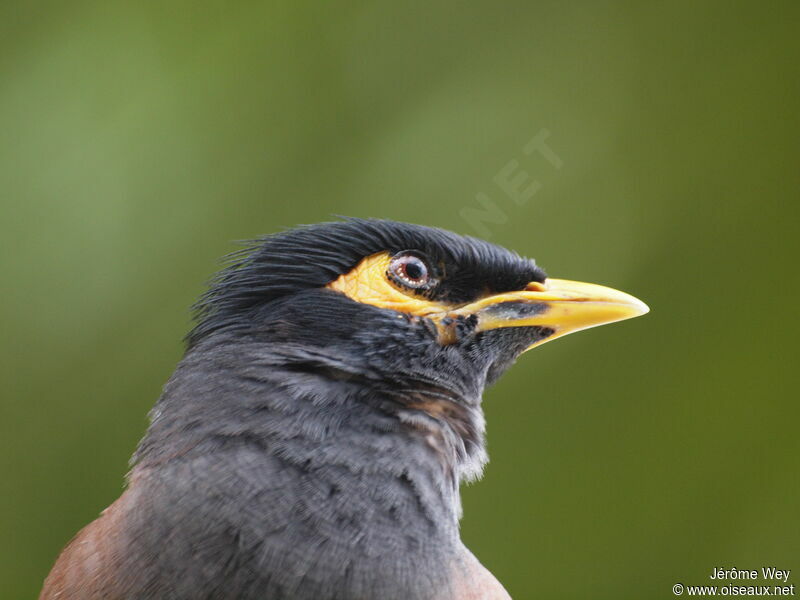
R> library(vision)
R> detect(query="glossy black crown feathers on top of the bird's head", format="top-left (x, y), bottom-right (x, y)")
top-left (187, 219), bottom-right (546, 347)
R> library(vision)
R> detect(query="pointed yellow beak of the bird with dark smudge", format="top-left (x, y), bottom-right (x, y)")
top-left (450, 279), bottom-right (650, 350)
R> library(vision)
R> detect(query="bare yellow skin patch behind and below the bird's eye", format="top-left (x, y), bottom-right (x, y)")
top-left (325, 252), bottom-right (453, 317)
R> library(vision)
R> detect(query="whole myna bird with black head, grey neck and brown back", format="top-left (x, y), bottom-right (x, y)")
top-left (39, 218), bottom-right (649, 600)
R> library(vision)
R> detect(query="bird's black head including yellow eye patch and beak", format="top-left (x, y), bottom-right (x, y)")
top-left (188, 219), bottom-right (648, 401)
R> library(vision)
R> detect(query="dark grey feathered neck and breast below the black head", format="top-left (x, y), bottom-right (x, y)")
top-left (126, 340), bottom-right (485, 600)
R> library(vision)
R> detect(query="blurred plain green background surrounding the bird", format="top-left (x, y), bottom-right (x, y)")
top-left (0, 1), bottom-right (800, 599)
